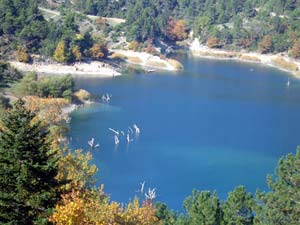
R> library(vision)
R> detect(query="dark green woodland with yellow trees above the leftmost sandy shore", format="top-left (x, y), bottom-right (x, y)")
top-left (0, 0), bottom-right (107, 63)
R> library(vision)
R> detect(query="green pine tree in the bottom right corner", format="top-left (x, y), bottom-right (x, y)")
top-left (255, 147), bottom-right (300, 225)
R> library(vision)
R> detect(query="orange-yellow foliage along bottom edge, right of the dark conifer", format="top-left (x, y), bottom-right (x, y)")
top-left (50, 189), bottom-right (158, 225)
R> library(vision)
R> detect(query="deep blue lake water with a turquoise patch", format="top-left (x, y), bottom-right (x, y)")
top-left (68, 53), bottom-right (300, 210)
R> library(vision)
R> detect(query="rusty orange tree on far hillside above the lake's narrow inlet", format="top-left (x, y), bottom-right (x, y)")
top-left (167, 18), bottom-right (187, 41)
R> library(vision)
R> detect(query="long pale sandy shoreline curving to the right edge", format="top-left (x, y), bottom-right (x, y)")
top-left (190, 39), bottom-right (300, 78)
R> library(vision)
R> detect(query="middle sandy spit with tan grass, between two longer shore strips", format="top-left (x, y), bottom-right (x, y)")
top-left (112, 49), bottom-right (183, 71)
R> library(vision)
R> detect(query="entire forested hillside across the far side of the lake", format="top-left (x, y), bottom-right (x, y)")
top-left (0, 0), bottom-right (300, 62)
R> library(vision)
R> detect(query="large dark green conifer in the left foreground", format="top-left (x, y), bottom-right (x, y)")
top-left (0, 100), bottom-right (60, 225)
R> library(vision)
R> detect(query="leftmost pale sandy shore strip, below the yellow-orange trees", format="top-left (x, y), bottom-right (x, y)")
top-left (9, 61), bottom-right (121, 77)
